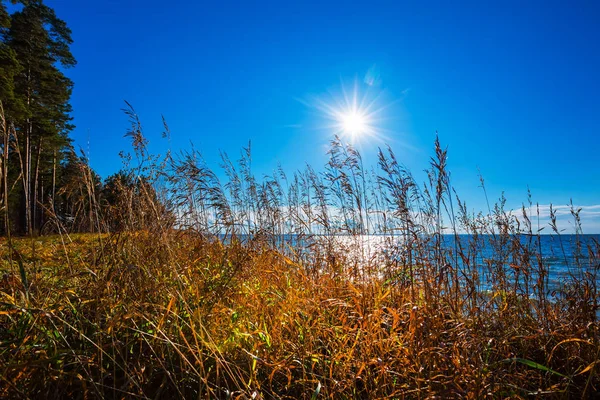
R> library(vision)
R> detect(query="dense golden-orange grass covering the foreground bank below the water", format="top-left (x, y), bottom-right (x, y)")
top-left (0, 231), bottom-right (600, 399)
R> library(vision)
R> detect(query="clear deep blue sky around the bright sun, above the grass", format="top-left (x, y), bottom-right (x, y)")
top-left (38, 0), bottom-right (600, 233)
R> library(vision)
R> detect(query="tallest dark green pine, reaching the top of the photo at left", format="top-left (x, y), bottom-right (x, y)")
top-left (4, 0), bottom-right (75, 234)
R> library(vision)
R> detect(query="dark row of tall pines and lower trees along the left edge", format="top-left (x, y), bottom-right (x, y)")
top-left (0, 0), bottom-right (142, 235)
